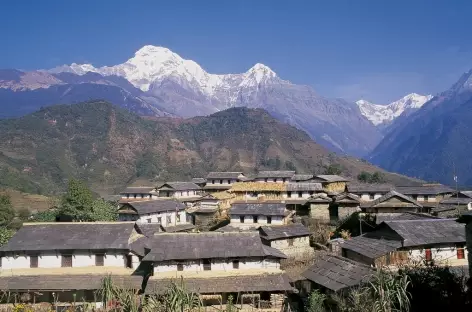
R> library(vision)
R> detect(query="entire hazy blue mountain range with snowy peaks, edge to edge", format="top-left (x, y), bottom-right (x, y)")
top-left (0, 46), bottom-right (472, 184)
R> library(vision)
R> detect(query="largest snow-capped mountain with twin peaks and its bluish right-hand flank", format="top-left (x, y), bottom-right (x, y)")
top-left (48, 45), bottom-right (382, 156)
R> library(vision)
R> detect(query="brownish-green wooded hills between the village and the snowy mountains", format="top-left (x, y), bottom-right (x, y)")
top-left (0, 102), bottom-right (411, 193)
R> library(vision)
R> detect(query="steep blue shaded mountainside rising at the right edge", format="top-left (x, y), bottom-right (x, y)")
top-left (371, 71), bottom-right (472, 186)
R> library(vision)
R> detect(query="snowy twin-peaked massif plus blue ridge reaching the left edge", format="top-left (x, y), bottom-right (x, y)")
top-left (0, 46), bottom-right (382, 156)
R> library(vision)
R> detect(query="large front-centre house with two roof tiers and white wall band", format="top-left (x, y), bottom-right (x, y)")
top-left (143, 232), bottom-right (294, 310)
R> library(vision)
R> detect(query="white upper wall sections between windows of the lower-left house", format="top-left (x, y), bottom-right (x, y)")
top-left (2, 251), bottom-right (135, 269)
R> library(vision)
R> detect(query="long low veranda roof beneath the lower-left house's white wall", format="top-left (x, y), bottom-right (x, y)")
top-left (0, 274), bottom-right (143, 291)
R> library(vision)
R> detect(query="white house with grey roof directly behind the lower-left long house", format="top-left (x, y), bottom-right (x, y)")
top-left (118, 199), bottom-right (191, 227)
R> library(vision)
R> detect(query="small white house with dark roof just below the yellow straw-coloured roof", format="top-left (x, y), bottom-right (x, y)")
top-left (229, 201), bottom-right (291, 228)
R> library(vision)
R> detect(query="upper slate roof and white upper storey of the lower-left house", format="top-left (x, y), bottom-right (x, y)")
top-left (0, 222), bottom-right (139, 269)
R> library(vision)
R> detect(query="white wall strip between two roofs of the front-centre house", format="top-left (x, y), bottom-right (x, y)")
top-left (154, 258), bottom-right (280, 274)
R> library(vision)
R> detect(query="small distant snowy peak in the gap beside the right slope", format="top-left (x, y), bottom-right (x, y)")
top-left (356, 93), bottom-right (433, 126)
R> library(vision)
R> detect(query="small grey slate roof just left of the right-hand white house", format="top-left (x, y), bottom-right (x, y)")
top-left (341, 234), bottom-right (401, 259)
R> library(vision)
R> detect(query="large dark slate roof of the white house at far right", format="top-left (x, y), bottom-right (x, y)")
top-left (379, 219), bottom-right (465, 247)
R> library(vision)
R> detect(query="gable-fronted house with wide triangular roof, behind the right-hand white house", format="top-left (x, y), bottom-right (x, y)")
top-left (361, 191), bottom-right (422, 214)
